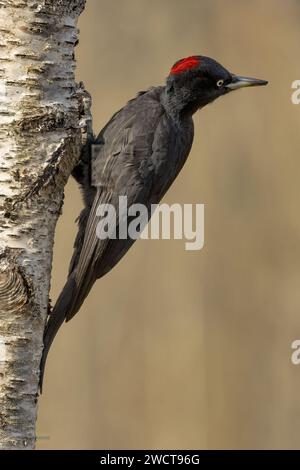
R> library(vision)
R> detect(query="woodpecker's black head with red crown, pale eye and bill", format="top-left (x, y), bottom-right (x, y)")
top-left (166, 56), bottom-right (268, 113)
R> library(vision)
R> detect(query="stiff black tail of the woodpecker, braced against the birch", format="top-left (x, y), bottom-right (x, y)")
top-left (39, 275), bottom-right (76, 393)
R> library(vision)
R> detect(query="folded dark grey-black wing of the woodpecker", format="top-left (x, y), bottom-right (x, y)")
top-left (66, 88), bottom-right (164, 320)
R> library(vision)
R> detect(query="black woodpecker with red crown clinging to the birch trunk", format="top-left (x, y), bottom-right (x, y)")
top-left (40, 55), bottom-right (268, 392)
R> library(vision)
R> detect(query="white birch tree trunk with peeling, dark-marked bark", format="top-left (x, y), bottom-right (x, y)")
top-left (0, 0), bottom-right (90, 449)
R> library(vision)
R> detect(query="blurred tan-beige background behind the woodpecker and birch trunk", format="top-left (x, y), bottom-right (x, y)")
top-left (38, 0), bottom-right (300, 449)
